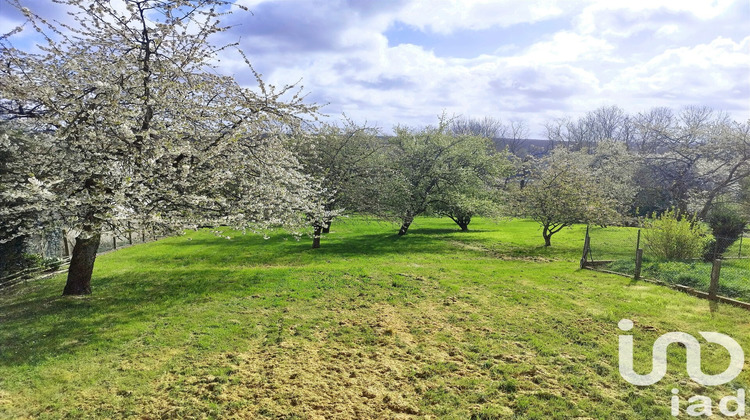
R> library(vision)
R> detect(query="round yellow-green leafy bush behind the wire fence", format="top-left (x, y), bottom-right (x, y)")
top-left (643, 209), bottom-right (710, 261)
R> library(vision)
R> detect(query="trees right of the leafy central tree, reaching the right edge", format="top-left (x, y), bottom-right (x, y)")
top-left (520, 107), bottom-right (750, 245)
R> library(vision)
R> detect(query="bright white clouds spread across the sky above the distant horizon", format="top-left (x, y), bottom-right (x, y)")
top-left (234, 0), bottom-right (750, 136)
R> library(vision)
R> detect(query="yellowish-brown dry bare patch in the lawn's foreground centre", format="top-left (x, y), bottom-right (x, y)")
top-left (139, 302), bottom-right (488, 419)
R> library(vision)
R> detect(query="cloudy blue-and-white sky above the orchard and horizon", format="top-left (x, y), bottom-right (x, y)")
top-left (0, 0), bottom-right (750, 137)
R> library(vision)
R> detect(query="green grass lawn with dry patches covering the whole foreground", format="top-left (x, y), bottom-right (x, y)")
top-left (0, 218), bottom-right (750, 419)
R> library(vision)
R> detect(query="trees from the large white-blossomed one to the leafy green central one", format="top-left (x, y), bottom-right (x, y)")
top-left (0, 0), bottom-right (508, 295)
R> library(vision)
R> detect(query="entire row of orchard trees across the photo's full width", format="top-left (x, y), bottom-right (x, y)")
top-left (0, 0), bottom-right (750, 294)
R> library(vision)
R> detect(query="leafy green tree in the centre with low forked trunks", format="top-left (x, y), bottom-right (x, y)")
top-left (381, 116), bottom-right (511, 235)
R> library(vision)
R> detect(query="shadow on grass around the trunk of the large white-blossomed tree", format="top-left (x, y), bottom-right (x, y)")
top-left (0, 268), bottom-right (273, 366)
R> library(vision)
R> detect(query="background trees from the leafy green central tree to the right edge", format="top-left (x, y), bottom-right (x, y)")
top-left (302, 107), bottom-right (750, 246)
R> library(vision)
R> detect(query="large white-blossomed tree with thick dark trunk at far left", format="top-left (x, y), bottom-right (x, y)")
top-left (0, 0), bottom-right (315, 295)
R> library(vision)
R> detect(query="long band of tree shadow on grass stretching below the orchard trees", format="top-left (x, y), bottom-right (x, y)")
top-left (0, 223), bottom-right (556, 366)
